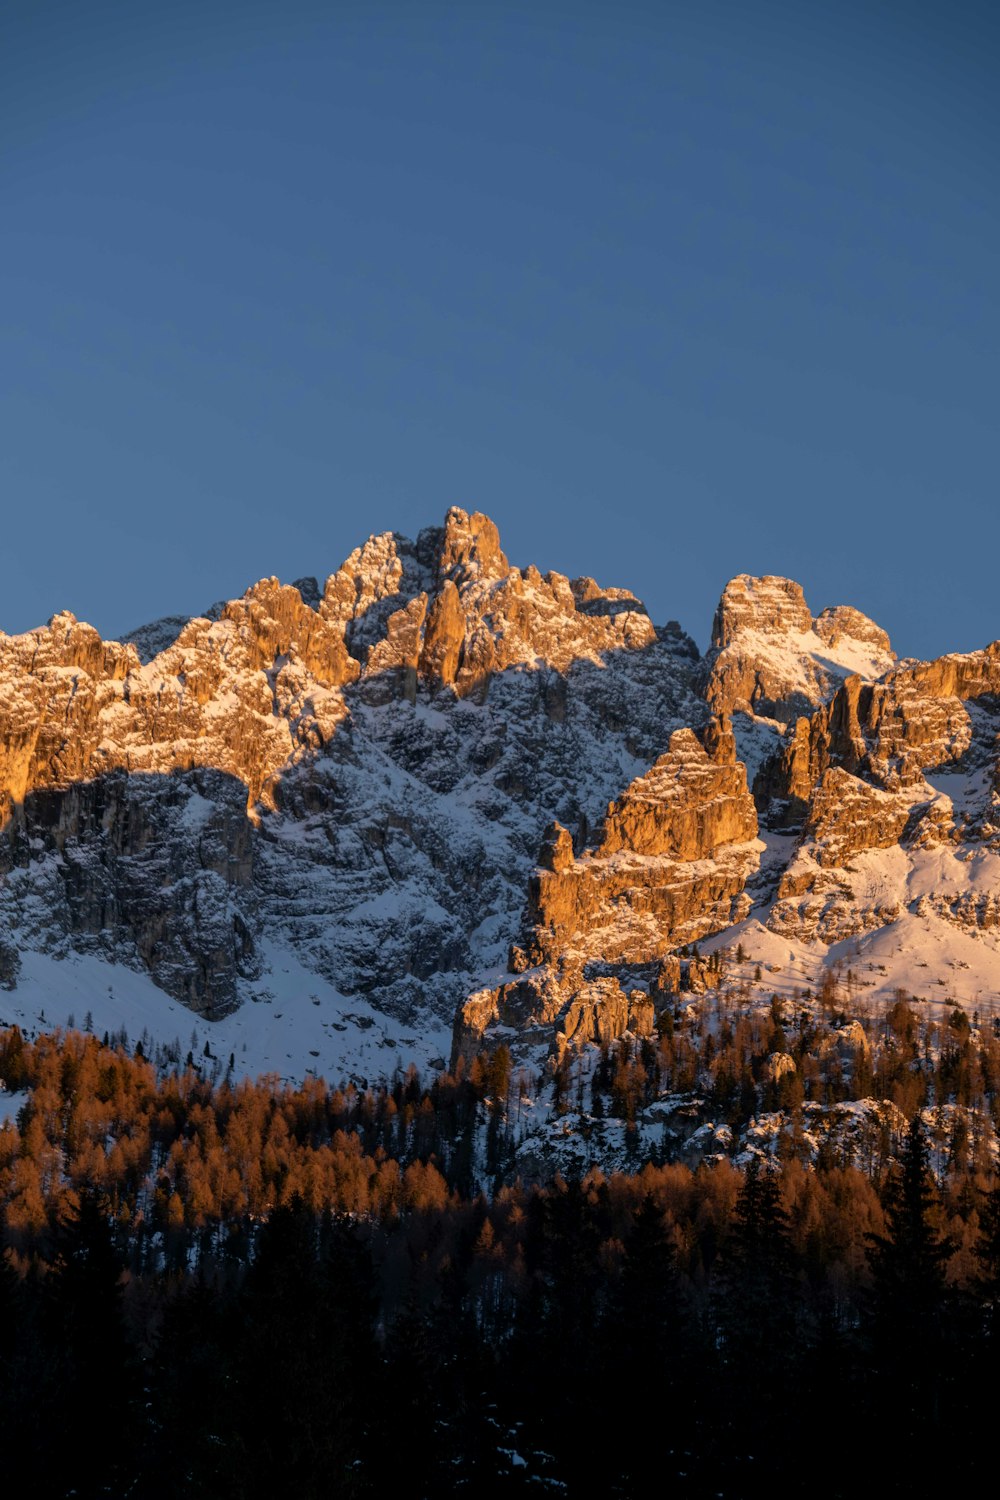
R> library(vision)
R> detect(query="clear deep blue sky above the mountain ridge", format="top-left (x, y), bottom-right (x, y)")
top-left (0, 0), bottom-right (1000, 656)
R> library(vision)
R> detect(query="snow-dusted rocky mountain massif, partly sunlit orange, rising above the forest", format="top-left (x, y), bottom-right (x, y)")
top-left (0, 509), bottom-right (1000, 1104)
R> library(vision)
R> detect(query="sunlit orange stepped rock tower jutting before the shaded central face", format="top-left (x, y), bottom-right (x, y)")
top-left (456, 722), bottom-right (762, 1056)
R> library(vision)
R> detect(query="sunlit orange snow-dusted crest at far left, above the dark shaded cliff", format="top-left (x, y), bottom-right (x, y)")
top-left (0, 579), bottom-right (358, 822)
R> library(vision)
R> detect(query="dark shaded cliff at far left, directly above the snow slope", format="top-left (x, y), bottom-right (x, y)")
top-left (0, 771), bottom-right (259, 1017)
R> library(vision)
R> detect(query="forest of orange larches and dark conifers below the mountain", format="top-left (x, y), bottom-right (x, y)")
top-left (0, 1001), bottom-right (1000, 1500)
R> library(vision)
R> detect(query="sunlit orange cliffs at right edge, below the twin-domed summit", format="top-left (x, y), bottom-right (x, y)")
top-left (757, 644), bottom-right (1000, 942)
